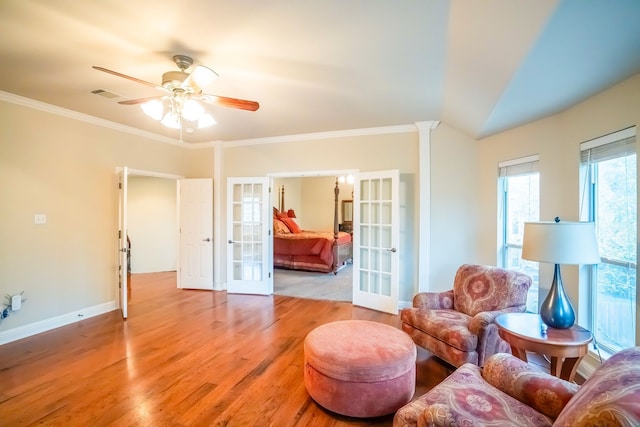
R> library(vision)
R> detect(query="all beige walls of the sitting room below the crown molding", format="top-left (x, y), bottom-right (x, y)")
top-left (0, 75), bottom-right (640, 344)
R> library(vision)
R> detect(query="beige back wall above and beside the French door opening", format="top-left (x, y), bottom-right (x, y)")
top-left (222, 130), bottom-right (419, 301)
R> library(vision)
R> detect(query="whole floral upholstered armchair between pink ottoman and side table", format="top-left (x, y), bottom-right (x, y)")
top-left (400, 264), bottom-right (531, 367)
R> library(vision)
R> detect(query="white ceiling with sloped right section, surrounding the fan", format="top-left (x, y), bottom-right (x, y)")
top-left (0, 0), bottom-right (640, 142)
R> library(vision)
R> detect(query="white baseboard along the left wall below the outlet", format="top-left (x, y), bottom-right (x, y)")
top-left (0, 301), bottom-right (118, 345)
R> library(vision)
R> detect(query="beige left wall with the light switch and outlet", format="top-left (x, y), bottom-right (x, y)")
top-left (0, 102), bottom-right (213, 332)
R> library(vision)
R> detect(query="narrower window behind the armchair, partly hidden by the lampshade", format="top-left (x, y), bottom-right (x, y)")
top-left (498, 156), bottom-right (540, 313)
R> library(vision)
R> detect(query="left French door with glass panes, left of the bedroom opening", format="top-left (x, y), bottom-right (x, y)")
top-left (227, 177), bottom-right (273, 295)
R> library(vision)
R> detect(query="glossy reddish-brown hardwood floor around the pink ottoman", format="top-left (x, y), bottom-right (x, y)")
top-left (0, 272), bottom-right (451, 426)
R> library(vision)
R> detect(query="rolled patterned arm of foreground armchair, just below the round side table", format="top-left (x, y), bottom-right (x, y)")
top-left (482, 353), bottom-right (580, 419)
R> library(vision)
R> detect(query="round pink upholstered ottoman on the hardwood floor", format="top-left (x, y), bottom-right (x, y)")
top-left (304, 320), bottom-right (416, 418)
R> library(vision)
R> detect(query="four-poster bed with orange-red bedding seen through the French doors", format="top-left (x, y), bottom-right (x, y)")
top-left (273, 180), bottom-right (353, 274)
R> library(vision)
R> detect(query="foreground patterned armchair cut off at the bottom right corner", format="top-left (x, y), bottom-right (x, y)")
top-left (393, 347), bottom-right (640, 427)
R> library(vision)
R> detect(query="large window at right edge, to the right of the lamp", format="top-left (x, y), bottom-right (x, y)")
top-left (580, 128), bottom-right (637, 353)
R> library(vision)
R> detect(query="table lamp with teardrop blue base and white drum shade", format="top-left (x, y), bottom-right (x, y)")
top-left (522, 217), bottom-right (600, 329)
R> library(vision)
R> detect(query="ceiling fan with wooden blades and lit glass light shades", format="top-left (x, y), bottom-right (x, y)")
top-left (93, 55), bottom-right (260, 134)
